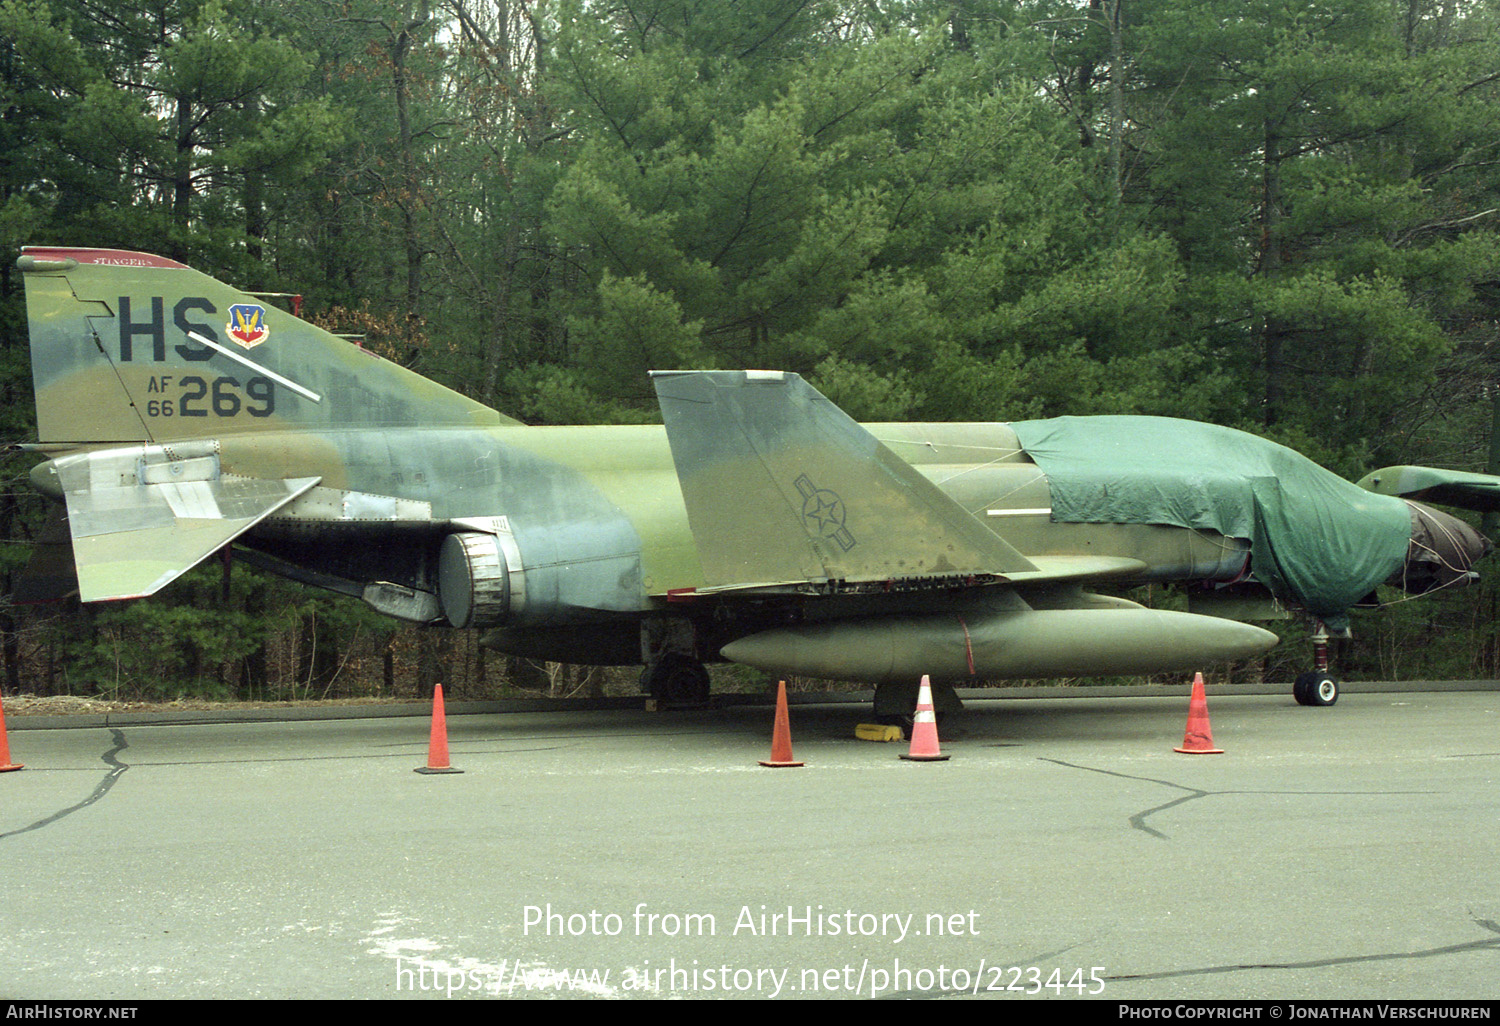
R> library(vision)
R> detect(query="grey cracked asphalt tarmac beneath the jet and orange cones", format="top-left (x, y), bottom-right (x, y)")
top-left (0, 686), bottom-right (1500, 1001)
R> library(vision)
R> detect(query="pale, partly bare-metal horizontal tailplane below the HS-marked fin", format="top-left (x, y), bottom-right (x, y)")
top-left (28, 443), bottom-right (321, 602)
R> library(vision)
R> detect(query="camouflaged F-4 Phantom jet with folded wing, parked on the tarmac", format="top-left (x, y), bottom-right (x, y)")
top-left (8, 248), bottom-right (1496, 711)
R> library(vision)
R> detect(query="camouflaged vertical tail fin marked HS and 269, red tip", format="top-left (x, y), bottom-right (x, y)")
top-left (18, 248), bottom-right (506, 443)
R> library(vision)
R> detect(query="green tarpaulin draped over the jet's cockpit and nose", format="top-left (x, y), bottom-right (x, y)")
top-left (1011, 417), bottom-right (1412, 620)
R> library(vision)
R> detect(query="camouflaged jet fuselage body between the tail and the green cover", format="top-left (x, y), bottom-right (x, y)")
top-left (219, 425), bottom-right (1247, 663)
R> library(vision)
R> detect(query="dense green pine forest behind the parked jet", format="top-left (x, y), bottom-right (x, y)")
top-left (0, 0), bottom-right (1500, 699)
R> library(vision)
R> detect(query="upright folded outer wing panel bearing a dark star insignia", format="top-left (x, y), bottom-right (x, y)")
top-left (653, 371), bottom-right (1037, 588)
